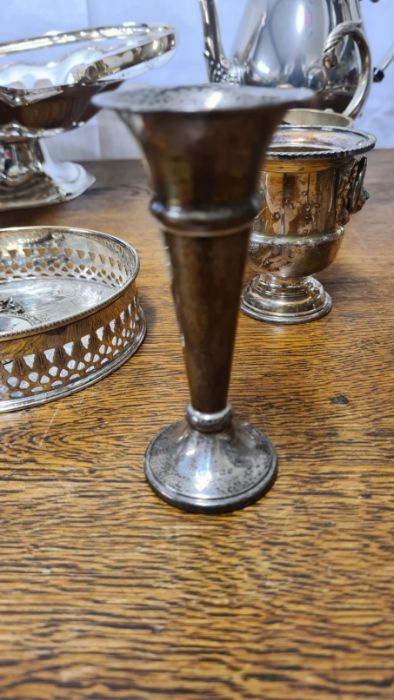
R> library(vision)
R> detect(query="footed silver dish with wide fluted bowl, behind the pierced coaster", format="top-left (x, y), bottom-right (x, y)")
top-left (0, 22), bottom-right (175, 211)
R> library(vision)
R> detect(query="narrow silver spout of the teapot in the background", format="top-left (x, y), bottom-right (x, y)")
top-left (199, 0), bottom-right (241, 83)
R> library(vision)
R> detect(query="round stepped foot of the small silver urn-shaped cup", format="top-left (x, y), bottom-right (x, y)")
top-left (241, 275), bottom-right (332, 324)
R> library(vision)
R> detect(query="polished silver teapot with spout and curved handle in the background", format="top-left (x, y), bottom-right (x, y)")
top-left (199, 0), bottom-right (393, 118)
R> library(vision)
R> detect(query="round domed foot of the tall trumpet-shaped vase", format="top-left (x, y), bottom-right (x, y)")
top-left (145, 407), bottom-right (276, 513)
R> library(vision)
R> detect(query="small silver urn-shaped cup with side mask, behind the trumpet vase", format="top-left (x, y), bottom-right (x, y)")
top-left (241, 126), bottom-right (375, 324)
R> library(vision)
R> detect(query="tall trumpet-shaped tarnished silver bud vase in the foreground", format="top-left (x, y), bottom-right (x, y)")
top-left (95, 85), bottom-right (312, 513)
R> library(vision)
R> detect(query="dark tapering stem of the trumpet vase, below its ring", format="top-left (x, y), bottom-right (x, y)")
top-left (164, 227), bottom-right (249, 413)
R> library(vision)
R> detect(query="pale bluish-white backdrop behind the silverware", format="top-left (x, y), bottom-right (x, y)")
top-left (0, 0), bottom-right (394, 160)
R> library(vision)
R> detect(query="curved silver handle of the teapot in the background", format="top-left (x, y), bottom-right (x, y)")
top-left (323, 22), bottom-right (372, 119)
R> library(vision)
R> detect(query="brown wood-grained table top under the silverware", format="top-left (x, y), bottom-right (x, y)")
top-left (0, 151), bottom-right (394, 700)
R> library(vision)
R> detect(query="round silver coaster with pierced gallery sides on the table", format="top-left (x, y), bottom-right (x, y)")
top-left (0, 226), bottom-right (146, 412)
